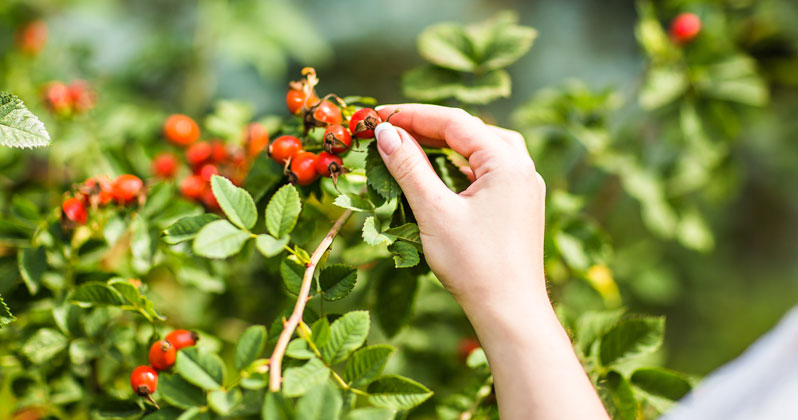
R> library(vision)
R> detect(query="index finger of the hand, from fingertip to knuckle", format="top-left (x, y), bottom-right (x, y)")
top-left (377, 104), bottom-right (504, 159)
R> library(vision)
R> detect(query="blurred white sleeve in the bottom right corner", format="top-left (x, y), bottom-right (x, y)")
top-left (660, 306), bottom-right (798, 420)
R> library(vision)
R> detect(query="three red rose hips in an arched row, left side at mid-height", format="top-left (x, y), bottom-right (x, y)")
top-left (61, 174), bottom-right (145, 225)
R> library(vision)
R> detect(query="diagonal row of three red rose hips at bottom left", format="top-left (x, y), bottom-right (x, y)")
top-left (130, 330), bottom-right (199, 407)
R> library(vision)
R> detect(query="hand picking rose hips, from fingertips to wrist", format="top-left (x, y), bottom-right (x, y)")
top-left (375, 104), bottom-right (546, 312)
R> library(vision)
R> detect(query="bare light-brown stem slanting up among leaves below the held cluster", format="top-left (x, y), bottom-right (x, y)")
top-left (269, 210), bottom-right (352, 392)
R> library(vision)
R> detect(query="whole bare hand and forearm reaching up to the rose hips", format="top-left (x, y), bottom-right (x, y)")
top-left (375, 104), bottom-right (609, 420)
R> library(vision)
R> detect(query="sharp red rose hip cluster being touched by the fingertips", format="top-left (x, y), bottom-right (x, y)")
top-left (269, 67), bottom-right (390, 185)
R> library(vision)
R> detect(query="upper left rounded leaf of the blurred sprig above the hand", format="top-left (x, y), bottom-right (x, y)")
top-left (418, 23), bottom-right (477, 72)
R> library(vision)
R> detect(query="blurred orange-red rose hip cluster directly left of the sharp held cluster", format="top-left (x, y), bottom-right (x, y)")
top-left (159, 114), bottom-right (269, 211)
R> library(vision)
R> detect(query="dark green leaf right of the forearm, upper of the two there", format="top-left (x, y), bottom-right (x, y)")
top-left (599, 317), bottom-right (665, 366)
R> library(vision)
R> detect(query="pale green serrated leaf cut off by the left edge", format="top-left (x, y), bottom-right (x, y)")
top-left (0, 92), bottom-right (50, 148)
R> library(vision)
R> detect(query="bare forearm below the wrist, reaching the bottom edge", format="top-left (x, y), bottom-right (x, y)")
top-left (464, 279), bottom-right (608, 420)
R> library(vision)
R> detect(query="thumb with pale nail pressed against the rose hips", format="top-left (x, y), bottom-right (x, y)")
top-left (374, 122), bottom-right (454, 212)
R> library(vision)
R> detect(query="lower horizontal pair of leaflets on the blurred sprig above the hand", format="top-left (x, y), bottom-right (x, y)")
top-left (404, 66), bottom-right (512, 105)
